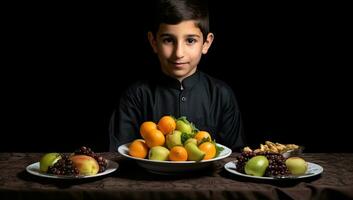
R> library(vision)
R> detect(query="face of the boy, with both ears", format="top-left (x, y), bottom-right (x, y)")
top-left (148, 20), bottom-right (213, 81)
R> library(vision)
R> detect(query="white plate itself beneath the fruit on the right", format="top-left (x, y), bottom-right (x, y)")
top-left (224, 161), bottom-right (324, 180)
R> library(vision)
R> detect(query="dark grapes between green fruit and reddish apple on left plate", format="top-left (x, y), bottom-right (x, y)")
top-left (48, 155), bottom-right (79, 175)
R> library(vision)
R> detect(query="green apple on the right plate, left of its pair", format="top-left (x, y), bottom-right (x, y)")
top-left (245, 155), bottom-right (269, 176)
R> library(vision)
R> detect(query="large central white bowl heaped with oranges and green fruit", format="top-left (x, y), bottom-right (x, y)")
top-left (118, 116), bottom-right (232, 174)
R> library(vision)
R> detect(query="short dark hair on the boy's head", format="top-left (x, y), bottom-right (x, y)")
top-left (150, 0), bottom-right (209, 39)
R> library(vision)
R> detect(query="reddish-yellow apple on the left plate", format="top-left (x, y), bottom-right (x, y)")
top-left (70, 155), bottom-right (99, 176)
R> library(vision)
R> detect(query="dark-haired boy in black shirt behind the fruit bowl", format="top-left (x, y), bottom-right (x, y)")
top-left (110, 0), bottom-right (244, 151)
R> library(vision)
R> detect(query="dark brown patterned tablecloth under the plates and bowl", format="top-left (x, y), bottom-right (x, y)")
top-left (0, 153), bottom-right (353, 200)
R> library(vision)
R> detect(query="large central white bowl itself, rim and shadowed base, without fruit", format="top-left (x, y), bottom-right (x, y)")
top-left (118, 143), bottom-right (232, 174)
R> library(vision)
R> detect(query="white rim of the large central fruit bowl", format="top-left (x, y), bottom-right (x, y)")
top-left (118, 143), bottom-right (232, 165)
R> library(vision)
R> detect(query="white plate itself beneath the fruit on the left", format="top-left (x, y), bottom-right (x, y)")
top-left (26, 160), bottom-right (119, 179)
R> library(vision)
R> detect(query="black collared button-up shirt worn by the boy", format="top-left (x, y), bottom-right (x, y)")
top-left (110, 71), bottom-right (244, 151)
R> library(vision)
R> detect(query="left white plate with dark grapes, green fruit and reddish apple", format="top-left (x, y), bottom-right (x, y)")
top-left (26, 146), bottom-right (119, 179)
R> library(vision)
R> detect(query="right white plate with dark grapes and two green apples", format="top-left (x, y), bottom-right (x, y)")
top-left (224, 141), bottom-right (323, 180)
